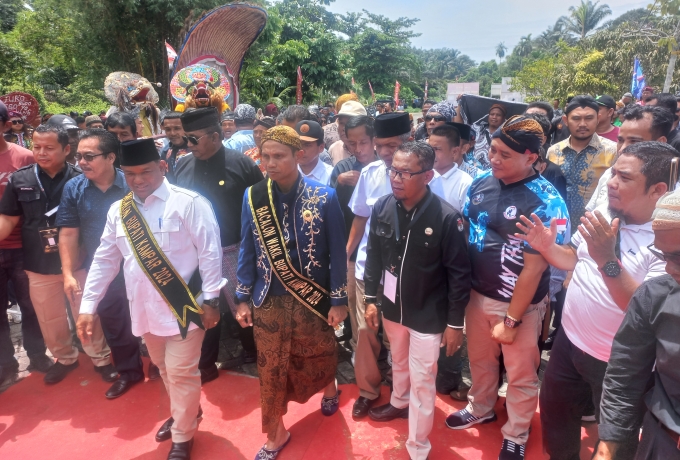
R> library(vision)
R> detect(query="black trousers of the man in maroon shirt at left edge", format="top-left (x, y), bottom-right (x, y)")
top-left (0, 249), bottom-right (46, 367)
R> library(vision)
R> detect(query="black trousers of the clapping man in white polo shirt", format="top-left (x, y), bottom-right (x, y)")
top-left (539, 329), bottom-right (637, 460)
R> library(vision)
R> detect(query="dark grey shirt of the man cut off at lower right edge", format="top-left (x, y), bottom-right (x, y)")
top-left (599, 275), bottom-right (680, 442)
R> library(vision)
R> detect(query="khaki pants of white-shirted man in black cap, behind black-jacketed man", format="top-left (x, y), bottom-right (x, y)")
top-left (352, 279), bottom-right (392, 400)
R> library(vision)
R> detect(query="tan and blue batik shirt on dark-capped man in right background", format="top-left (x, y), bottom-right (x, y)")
top-left (548, 134), bottom-right (616, 222)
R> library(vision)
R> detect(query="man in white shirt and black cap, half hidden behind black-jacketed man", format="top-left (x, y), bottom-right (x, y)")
top-left (354, 113), bottom-right (411, 418)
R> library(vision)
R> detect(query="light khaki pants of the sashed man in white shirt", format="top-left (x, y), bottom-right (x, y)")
top-left (143, 328), bottom-right (205, 442)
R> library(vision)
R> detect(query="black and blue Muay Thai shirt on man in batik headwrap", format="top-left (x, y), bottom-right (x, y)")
top-left (463, 171), bottom-right (569, 303)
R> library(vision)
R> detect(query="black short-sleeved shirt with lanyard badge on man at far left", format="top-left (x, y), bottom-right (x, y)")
top-left (0, 163), bottom-right (81, 275)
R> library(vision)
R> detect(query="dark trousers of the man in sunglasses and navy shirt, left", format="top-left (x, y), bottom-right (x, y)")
top-left (97, 273), bottom-right (144, 381)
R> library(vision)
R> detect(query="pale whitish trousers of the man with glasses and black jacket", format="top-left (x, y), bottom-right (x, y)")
top-left (383, 318), bottom-right (442, 460)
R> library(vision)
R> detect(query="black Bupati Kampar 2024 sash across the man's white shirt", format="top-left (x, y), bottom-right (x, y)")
top-left (120, 192), bottom-right (204, 339)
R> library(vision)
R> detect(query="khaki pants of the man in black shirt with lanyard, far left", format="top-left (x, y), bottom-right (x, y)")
top-left (26, 270), bottom-right (111, 367)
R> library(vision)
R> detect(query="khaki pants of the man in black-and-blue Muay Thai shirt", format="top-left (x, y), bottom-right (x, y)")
top-left (465, 290), bottom-right (547, 444)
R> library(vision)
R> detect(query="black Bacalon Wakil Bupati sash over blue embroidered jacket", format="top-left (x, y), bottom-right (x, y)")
top-left (248, 179), bottom-right (331, 321)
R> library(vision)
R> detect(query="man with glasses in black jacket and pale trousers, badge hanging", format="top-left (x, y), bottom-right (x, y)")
top-left (364, 142), bottom-right (471, 460)
